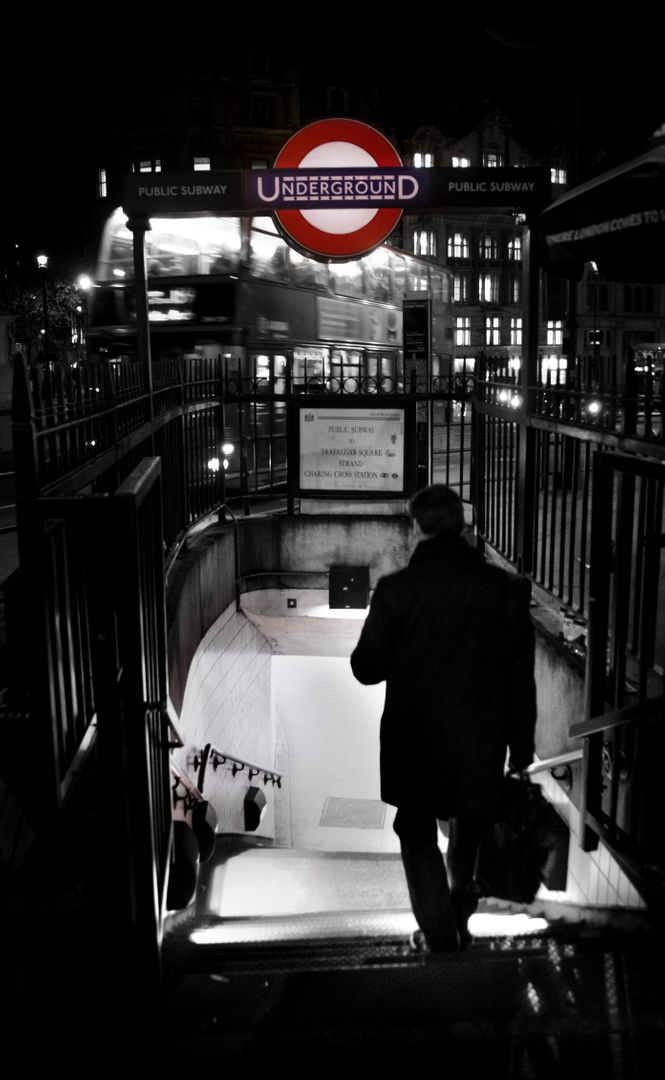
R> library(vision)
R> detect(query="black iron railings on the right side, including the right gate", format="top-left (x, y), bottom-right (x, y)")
top-left (473, 356), bottom-right (665, 907)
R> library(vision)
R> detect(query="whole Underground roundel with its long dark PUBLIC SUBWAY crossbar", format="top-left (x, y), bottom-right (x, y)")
top-left (123, 119), bottom-right (551, 259)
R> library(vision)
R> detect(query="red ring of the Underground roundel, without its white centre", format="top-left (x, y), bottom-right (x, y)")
top-left (274, 118), bottom-right (403, 258)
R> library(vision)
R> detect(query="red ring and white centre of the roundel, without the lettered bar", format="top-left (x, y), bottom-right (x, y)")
top-left (273, 118), bottom-right (402, 260)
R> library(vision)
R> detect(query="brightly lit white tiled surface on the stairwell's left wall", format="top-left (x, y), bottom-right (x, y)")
top-left (174, 604), bottom-right (275, 836)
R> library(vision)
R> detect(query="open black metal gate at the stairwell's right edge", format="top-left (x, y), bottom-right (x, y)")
top-left (570, 451), bottom-right (665, 904)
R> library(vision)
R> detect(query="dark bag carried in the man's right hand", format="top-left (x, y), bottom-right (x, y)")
top-left (475, 775), bottom-right (569, 904)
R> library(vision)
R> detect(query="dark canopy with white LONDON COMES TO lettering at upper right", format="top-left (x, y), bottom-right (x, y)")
top-left (538, 132), bottom-right (665, 282)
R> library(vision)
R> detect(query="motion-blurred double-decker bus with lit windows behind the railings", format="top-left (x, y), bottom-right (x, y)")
top-left (87, 210), bottom-right (452, 490)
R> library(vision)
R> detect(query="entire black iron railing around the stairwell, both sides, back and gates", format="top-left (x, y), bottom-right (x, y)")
top-left (13, 339), bottom-right (665, 972)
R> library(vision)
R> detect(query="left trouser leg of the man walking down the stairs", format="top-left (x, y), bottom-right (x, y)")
top-left (393, 808), bottom-right (459, 953)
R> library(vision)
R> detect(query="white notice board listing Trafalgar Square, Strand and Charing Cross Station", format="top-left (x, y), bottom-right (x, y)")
top-left (299, 405), bottom-right (405, 495)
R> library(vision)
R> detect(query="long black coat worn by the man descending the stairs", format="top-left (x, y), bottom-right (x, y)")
top-left (351, 537), bottom-right (537, 819)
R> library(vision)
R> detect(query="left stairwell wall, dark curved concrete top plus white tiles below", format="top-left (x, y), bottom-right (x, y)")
top-left (166, 525), bottom-right (275, 837)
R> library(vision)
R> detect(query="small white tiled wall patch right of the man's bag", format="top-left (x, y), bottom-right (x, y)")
top-left (534, 772), bottom-right (646, 910)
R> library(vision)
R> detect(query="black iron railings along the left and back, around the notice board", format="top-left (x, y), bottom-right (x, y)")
top-left (13, 345), bottom-right (473, 537)
